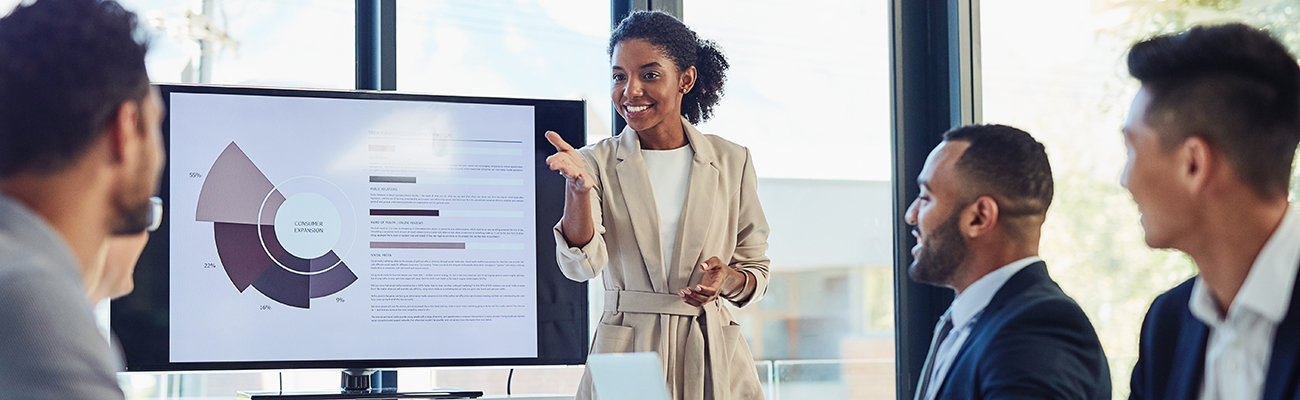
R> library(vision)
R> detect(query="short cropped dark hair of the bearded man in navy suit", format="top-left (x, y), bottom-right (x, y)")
top-left (944, 125), bottom-right (1053, 217)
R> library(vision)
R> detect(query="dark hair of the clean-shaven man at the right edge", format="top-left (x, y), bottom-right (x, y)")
top-left (1128, 23), bottom-right (1300, 196)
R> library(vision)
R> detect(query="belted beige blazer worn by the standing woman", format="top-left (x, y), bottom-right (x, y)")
top-left (555, 118), bottom-right (770, 400)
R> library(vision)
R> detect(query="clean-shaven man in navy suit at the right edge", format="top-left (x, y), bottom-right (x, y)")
top-left (1122, 23), bottom-right (1300, 400)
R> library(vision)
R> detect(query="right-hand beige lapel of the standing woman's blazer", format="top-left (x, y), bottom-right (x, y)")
top-left (670, 118), bottom-right (731, 290)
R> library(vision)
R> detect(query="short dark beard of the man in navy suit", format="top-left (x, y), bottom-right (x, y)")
top-left (907, 206), bottom-right (970, 284)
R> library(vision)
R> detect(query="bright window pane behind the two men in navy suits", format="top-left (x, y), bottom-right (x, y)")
top-left (980, 0), bottom-right (1300, 399)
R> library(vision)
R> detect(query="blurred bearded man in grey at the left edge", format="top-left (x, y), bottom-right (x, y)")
top-left (0, 0), bottom-right (164, 399)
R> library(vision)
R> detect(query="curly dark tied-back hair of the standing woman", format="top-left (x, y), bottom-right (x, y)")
top-left (606, 12), bottom-right (731, 123)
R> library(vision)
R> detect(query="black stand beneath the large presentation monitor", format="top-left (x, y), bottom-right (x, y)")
top-left (239, 369), bottom-right (484, 400)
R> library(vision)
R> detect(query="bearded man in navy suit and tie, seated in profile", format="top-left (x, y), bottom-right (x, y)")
top-left (906, 125), bottom-right (1112, 400)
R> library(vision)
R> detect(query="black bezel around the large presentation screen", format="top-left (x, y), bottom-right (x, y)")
top-left (109, 84), bottom-right (589, 371)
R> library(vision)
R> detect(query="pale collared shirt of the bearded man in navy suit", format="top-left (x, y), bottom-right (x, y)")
top-left (922, 256), bottom-right (1043, 400)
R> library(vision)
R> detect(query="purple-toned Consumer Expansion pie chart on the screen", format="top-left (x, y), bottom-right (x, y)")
top-left (195, 142), bottom-right (356, 309)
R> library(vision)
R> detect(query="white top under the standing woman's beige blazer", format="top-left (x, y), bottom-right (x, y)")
top-left (641, 145), bottom-right (696, 282)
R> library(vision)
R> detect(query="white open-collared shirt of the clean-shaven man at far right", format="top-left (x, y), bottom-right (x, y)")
top-left (1188, 206), bottom-right (1300, 400)
